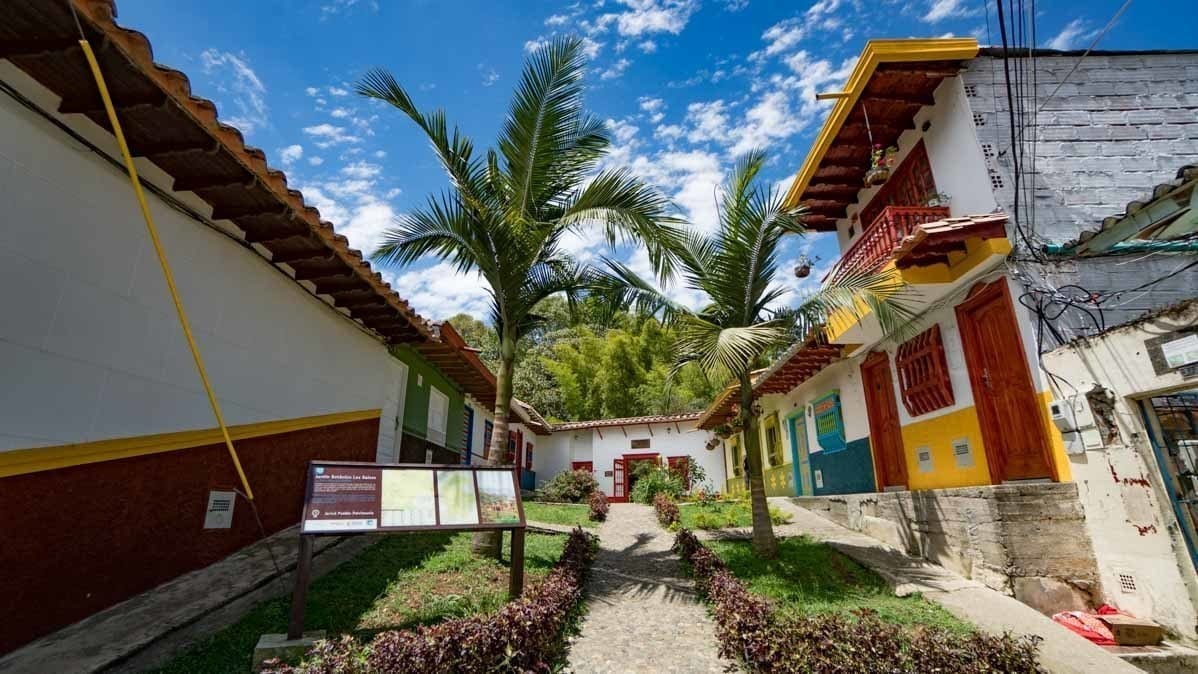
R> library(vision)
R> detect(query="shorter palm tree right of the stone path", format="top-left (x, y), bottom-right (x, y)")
top-left (597, 152), bottom-right (912, 557)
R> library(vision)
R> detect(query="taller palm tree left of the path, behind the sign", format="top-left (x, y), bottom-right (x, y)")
top-left (357, 38), bottom-right (674, 557)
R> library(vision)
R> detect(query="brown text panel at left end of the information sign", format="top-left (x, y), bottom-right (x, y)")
top-left (303, 466), bottom-right (379, 532)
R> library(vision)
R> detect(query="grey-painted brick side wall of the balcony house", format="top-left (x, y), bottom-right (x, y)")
top-left (963, 51), bottom-right (1198, 351)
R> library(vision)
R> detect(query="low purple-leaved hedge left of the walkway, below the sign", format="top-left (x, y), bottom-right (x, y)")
top-left (264, 529), bottom-right (595, 674)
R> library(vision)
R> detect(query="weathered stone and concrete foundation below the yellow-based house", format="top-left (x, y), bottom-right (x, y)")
top-left (793, 482), bottom-right (1100, 614)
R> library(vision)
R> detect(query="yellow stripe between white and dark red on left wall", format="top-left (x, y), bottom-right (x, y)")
top-left (0, 409), bottom-right (382, 478)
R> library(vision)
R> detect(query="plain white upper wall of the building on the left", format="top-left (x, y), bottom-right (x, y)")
top-left (0, 63), bottom-right (403, 459)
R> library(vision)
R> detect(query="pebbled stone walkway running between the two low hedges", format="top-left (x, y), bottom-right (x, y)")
top-left (569, 503), bottom-right (727, 674)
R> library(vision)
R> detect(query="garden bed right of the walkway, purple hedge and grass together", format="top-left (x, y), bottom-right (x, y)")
top-left (676, 529), bottom-right (1043, 674)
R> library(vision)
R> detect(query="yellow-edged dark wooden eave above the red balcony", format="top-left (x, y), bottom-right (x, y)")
top-left (786, 38), bottom-right (978, 231)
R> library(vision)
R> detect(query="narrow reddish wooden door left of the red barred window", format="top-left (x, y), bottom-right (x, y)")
top-left (861, 351), bottom-right (907, 491)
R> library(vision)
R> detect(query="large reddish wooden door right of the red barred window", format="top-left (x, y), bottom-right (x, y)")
top-left (957, 279), bottom-right (1057, 484)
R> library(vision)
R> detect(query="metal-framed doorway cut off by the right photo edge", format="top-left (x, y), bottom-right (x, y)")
top-left (1142, 389), bottom-right (1198, 566)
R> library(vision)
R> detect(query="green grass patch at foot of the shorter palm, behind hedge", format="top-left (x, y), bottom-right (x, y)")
top-left (706, 536), bottom-right (973, 633)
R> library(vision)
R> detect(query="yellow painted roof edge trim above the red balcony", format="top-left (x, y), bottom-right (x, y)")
top-left (786, 37), bottom-right (978, 206)
